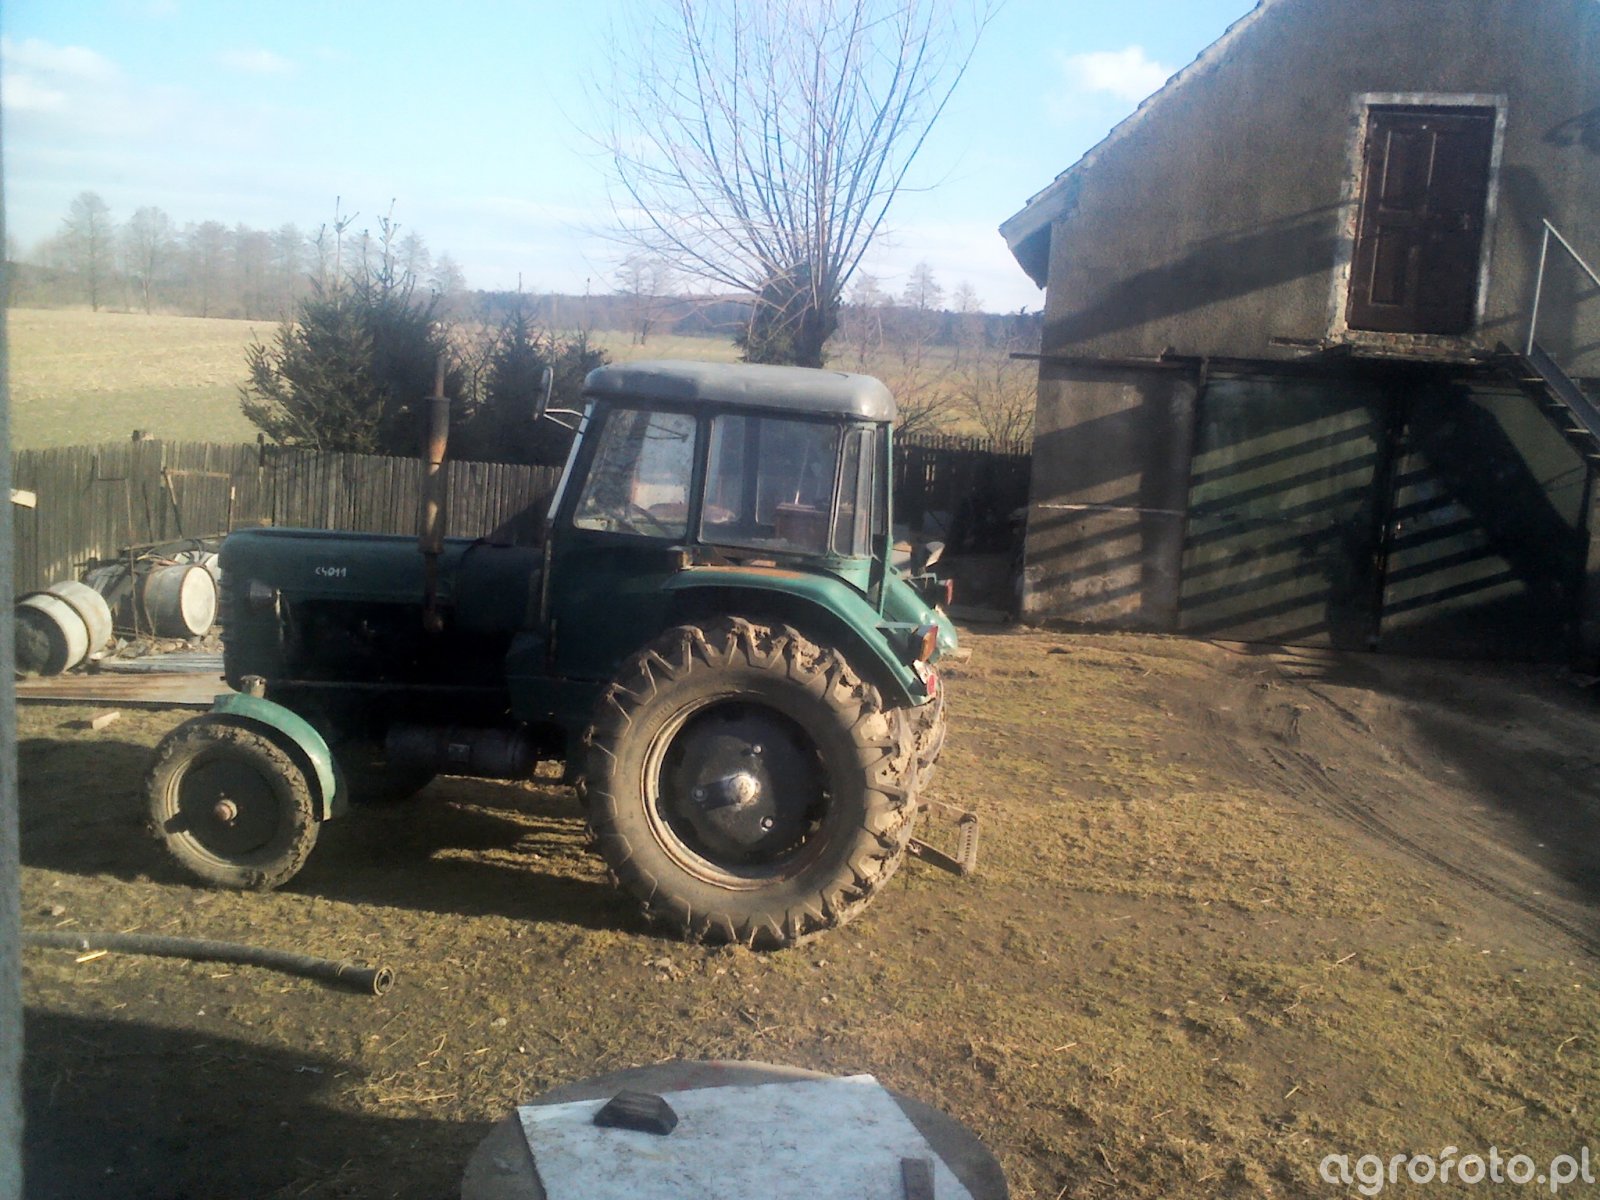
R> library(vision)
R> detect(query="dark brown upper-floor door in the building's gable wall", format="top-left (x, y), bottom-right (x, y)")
top-left (1349, 107), bottom-right (1494, 334)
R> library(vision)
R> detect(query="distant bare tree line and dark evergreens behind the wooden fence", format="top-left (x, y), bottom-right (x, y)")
top-left (10, 183), bottom-right (1040, 462)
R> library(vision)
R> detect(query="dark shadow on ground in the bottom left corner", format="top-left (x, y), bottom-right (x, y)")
top-left (22, 1011), bottom-right (486, 1200)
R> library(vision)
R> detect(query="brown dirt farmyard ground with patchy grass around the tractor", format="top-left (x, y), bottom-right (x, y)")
top-left (19, 632), bottom-right (1600, 1200)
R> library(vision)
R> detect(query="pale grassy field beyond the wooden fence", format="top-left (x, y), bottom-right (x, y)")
top-left (6, 309), bottom-right (978, 450)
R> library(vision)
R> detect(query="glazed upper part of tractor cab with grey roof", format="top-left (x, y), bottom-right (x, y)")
top-left (555, 362), bottom-right (894, 590)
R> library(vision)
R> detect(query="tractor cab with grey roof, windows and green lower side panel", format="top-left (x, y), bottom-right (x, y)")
top-left (546, 362), bottom-right (954, 702)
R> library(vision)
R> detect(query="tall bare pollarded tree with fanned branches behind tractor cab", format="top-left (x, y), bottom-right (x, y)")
top-left (605, 0), bottom-right (990, 366)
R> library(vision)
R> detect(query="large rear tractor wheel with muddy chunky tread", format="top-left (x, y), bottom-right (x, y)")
top-left (584, 618), bottom-right (917, 947)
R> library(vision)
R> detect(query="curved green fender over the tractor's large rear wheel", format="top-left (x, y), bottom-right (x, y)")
top-left (662, 566), bottom-right (930, 709)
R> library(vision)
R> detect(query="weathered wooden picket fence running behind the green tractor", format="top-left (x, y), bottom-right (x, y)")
top-left (11, 437), bottom-right (1029, 594)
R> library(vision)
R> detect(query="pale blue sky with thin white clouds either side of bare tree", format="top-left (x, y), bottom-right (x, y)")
top-left (0, 0), bottom-right (1253, 312)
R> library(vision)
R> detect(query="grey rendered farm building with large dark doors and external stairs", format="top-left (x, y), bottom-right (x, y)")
top-left (1002, 0), bottom-right (1600, 658)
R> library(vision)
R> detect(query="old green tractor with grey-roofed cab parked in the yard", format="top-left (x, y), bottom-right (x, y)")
top-left (146, 362), bottom-right (976, 947)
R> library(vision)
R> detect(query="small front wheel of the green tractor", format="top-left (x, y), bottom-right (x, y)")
top-left (144, 717), bottom-right (318, 891)
